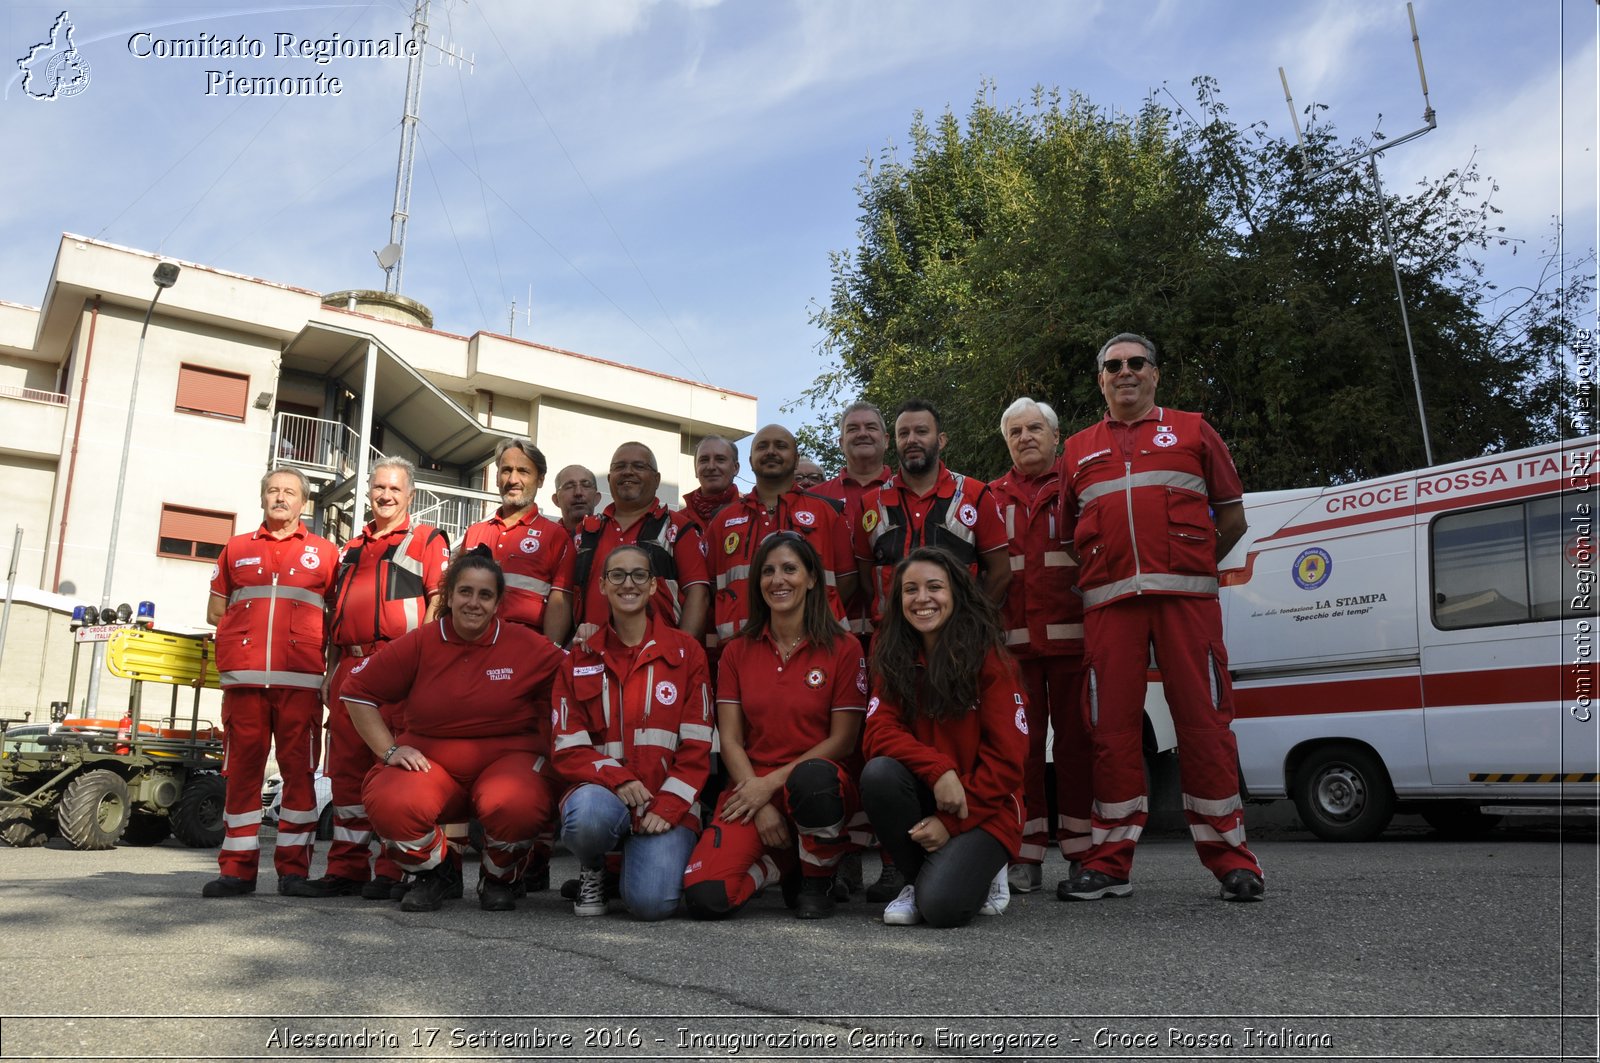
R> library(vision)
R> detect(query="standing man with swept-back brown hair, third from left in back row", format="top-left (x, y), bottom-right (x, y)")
top-left (461, 439), bottom-right (573, 645)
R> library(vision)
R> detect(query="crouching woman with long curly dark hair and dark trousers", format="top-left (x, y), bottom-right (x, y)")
top-left (861, 548), bottom-right (1027, 927)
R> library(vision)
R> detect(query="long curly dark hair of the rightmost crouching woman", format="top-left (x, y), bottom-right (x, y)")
top-left (872, 546), bottom-right (1005, 720)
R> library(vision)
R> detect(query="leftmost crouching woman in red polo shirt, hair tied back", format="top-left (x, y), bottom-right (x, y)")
top-left (342, 552), bottom-right (562, 911)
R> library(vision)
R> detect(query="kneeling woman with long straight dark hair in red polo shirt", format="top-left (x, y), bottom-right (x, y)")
top-left (683, 532), bottom-right (869, 919)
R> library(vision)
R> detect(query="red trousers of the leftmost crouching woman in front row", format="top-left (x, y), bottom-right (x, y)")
top-left (362, 735), bottom-right (555, 882)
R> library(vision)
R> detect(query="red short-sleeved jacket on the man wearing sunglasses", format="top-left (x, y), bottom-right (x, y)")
top-left (1061, 407), bottom-right (1245, 608)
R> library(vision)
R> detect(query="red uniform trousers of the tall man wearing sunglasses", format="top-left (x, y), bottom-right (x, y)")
top-left (1083, 594), bottom-right (1261, 879)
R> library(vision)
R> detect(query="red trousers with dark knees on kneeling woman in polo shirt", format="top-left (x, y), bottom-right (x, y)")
top-left (683, 765), bottom-right (872, 914)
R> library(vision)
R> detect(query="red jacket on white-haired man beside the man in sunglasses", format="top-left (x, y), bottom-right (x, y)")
top-left (989, 463), bottom-right (1083, 658)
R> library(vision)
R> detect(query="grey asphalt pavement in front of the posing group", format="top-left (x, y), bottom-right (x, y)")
top-left (0, 816), bottom-right (1600, 1060)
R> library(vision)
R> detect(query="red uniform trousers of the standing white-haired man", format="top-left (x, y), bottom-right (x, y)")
top-left (1016, 656), bottom-right (1094, 863)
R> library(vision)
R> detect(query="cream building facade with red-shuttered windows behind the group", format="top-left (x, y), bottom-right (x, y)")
top-left (0, 234), bottom-right (755, 720)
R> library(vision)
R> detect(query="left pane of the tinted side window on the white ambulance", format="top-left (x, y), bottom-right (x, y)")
top-left (1434, 503), bottom-right (1528, 629)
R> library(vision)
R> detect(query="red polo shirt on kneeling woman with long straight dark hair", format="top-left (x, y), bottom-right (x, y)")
top-left (717, 634), bottom-right (867, 775)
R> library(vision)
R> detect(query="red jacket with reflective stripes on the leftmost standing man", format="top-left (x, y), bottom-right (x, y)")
top-left (211, 523), bottom-right (339, 690)
